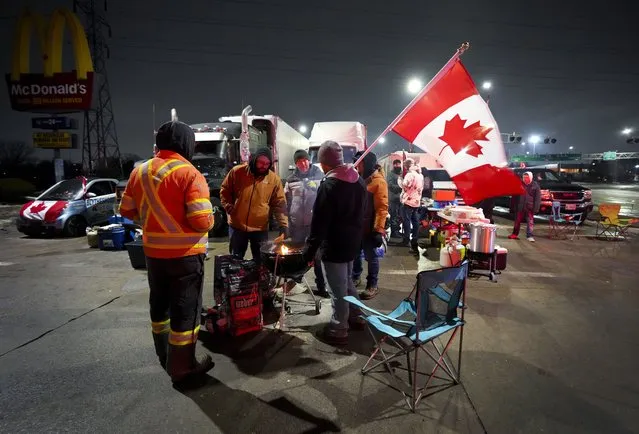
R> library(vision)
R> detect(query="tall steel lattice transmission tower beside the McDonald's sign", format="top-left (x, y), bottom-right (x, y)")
top-left (73, 0), bottom-right (122, 176)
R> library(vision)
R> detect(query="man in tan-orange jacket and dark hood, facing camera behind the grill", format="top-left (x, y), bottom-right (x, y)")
top-left (220, 148), bottom-right (288, 263)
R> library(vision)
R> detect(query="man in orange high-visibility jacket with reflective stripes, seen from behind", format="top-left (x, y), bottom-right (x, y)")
top-left (120, 121), bottom-right (214, 383)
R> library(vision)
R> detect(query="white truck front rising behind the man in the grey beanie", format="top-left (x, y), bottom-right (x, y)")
top-left (308, 121), bottom-right (367, 167)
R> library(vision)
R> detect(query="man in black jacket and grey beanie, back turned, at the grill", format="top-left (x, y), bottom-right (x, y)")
top-left (305, 141), bottom-right (367, 345)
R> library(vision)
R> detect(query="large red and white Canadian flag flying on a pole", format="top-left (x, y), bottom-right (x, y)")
top-left (393, 60), bottom-right (524, 204)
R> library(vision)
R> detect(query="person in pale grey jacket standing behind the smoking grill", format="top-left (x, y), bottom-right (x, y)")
top-left (284, 149), bottom-right (328, 297)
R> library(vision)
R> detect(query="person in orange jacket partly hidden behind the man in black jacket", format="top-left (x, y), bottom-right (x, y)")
top-left (353, 151), bottom-right (388, 300)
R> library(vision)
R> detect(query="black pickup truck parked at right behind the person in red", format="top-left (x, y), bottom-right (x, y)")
top-left (495, 168), bottom-right (593, 222)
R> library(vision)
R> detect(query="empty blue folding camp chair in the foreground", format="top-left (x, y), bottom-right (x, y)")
top-left (344, 261), bottom-right (468, 412)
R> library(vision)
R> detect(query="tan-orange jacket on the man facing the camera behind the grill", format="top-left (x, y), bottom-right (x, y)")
top-left (220, 164), bottom-right (288, 232)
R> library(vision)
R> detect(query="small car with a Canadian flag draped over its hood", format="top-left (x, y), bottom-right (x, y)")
top-left (16, 177), bottom-right (118, 237)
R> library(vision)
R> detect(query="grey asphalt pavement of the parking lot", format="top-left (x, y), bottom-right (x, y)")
top-left (0, 220), bottom-right (639, 433)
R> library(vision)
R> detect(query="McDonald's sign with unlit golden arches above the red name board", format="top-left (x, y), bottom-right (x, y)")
top-left (6, 9), bottom-right (94, 113)
